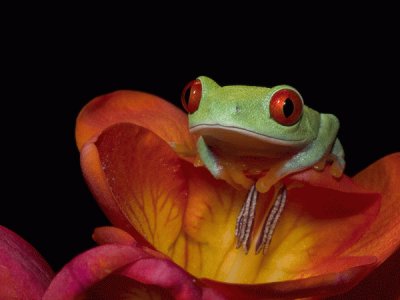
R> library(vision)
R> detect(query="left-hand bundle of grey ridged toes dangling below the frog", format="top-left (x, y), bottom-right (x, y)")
top-left (235, 185), bottom-right (258, 253)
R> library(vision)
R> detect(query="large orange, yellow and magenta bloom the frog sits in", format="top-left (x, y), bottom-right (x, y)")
top-left (44, 91), bottom-right (400, 299)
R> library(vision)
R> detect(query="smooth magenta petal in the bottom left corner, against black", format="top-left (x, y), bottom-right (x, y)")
top-left (0, 226), bottom-right (53, 300)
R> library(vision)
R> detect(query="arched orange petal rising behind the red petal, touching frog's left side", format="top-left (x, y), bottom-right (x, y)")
top-left (75, 91), bottom-right (195, 157)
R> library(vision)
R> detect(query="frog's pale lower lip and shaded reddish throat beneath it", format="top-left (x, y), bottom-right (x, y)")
top-left (189, 124), bottom-right (307, 157)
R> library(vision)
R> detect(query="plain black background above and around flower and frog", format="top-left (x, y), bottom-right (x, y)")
top-left (0, 6), bottom-right (400, 276)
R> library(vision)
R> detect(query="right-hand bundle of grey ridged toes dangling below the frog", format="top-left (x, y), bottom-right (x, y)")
top-left (256, 186), bottom-right (286, 254)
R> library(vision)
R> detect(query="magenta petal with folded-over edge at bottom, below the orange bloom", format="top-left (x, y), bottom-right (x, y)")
top-left (43, 244), bottom-right (201, 300)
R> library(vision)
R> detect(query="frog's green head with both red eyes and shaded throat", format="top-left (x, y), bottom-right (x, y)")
top-left (182, 76), bottom-right (320, 157)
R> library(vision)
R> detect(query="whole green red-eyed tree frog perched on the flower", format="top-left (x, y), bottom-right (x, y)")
top-left (181, 76), bottom-right (345, 254)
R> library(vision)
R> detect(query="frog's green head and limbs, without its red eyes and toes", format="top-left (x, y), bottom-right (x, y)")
top-left (188, 76), bottom-right (345, 189)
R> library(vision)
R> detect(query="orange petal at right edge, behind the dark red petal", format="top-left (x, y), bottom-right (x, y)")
top-left (346, 153), bottom-right (400, 262)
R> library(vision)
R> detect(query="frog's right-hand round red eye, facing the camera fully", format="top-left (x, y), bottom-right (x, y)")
top-left (269, 89), bottom-right (303, 126)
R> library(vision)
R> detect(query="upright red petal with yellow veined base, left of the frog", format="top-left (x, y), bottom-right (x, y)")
top-left (82, 123), bottom-right (186, 253)
